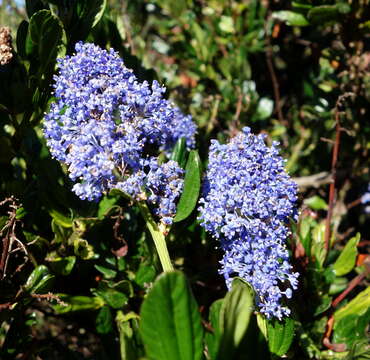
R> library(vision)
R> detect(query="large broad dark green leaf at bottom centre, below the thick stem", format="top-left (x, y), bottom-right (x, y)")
top-left (140, 271), bottom-right (203, 360)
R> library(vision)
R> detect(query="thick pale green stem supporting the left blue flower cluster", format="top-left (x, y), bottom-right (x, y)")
top-left (138, 201), bottom-right (173, 271)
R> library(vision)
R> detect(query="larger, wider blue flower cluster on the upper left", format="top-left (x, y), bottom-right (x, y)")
top-left (44, 43), bottom-right (196, 223)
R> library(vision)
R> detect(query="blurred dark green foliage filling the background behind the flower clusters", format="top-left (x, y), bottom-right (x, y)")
top-left (0, 0), bottom-right (370, 360)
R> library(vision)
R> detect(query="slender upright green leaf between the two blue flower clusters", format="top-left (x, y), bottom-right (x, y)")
top-left (174, 150), bottom-right (202, 222)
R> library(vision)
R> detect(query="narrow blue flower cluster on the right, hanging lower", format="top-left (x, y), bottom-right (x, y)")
top-left (199, 127), bottom-right (298, 319)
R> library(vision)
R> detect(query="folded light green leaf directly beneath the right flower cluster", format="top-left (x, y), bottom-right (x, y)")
top-left (217, 278), bottom-right (254, 359)
